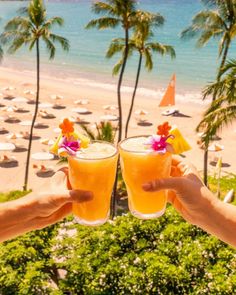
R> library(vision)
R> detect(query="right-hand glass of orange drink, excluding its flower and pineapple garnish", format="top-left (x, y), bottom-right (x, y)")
top-left (119, 136), bottom-right (171, 219)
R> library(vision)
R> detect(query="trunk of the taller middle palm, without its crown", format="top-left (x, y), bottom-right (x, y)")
top-left (117, 29), bottom-right (129, 142)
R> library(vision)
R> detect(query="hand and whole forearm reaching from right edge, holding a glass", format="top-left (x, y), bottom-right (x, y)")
top-left (143, 158), bottom-right (236, 247)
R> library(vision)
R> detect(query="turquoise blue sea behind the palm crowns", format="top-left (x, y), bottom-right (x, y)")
top-left (0, 0), bottom-right (236, 99)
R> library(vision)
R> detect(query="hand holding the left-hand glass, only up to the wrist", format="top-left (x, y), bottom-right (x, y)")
top-left (12, 168), bottom-right (93, 231)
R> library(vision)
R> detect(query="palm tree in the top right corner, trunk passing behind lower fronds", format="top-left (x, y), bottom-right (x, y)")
top-left (181, 0), bottom-right (236, 185)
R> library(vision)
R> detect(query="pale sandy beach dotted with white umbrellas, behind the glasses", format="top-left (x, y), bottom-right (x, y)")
top-left (0, 67), bottom-right (236, 191)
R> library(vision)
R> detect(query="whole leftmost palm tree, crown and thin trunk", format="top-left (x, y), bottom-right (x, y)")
top-left (1, 0), bottom-right (69, 190)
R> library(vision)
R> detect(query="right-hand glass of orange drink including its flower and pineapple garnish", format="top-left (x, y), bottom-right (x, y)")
top-left (119, 122), bottom-right (190, 219)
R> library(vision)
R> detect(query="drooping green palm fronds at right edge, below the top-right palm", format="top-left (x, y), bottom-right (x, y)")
top-left (197, 59), bottom-right (236, 145)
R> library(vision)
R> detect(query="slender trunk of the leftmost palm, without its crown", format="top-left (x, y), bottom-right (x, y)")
top-left (23, 39), bottom-right (40, 190)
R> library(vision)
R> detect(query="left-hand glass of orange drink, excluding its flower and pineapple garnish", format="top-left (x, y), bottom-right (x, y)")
top-left (68, 141), bottom-right (118, 226)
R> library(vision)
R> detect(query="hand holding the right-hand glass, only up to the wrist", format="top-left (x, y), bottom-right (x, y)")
top-left (143, 157), bottom-right (218, 227)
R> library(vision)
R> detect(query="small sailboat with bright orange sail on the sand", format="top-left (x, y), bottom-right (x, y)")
top-left (159, 74), bottom-right (178, 116)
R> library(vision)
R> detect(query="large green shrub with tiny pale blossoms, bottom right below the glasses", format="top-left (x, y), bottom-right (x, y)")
top-left (57, 207), bottom-right (236, 295)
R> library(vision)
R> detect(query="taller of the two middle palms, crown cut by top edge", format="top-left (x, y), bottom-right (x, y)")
top-left (86, 0), bottom-right (136, 142)
